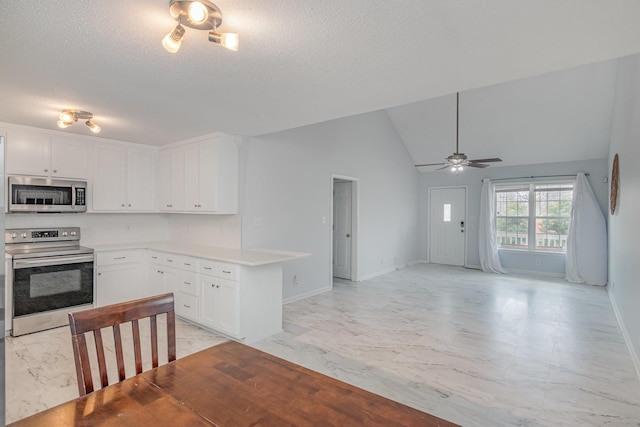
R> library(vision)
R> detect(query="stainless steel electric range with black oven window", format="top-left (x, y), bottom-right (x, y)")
top-left (5, 227), bottom-right (95, 336)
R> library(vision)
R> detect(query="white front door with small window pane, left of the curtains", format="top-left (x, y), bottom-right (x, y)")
top-left (429, 188), bottom-right (467, 266)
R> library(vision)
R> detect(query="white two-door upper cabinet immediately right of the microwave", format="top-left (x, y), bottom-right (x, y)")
top-left (91, 145), bottom-right (156, 212)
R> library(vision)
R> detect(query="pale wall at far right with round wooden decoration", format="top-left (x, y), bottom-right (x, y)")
top-left (608, 55), bottom-right (640, 375)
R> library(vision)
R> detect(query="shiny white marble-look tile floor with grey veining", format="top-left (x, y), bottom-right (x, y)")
top-left (7, 264), bottom-right (640, 426)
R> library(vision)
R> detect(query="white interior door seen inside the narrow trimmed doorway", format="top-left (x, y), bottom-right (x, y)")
top-left (333, 181), bottom-right (352, 280)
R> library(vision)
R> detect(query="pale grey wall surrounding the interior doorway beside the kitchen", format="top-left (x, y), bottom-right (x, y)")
top-left (241, 112), bottom-right (418, 299)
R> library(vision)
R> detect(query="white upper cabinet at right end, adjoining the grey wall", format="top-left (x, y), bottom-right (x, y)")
top-left (159, 136), bottom-right (239, 214)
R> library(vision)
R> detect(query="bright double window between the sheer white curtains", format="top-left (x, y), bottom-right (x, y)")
top-left (495, 182), bottom-right (573, 252)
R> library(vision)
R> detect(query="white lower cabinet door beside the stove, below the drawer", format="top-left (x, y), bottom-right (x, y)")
top-left (96, 263), bottom-right (145, 306)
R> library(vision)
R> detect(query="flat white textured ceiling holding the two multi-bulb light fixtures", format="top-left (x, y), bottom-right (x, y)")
top-left (0, 0), bottom-right (640, 147)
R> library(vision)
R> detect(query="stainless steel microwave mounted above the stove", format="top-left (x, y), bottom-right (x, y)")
top-left (8, 176), bottom-right (87, 213)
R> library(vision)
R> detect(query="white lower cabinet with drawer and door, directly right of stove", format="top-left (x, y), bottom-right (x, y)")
top-left (96, 249), bottom-right (147, 306)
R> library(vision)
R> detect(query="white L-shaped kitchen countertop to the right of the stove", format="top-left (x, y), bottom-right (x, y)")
top-left (90, 241), bottom-right (311, 266)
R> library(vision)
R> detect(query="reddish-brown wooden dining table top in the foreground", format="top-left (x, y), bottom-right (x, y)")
top-left (10, 341), bottom-right (457, 427)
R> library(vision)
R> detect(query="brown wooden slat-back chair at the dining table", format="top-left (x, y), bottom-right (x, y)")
top-left (69, 293), bottom-right (176, 397)
